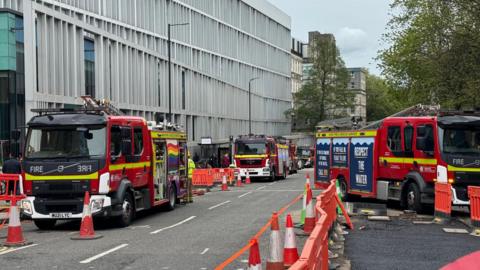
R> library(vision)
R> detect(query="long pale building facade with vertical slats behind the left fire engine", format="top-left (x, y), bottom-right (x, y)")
top-left (0, 0), bottom-right (292, 148)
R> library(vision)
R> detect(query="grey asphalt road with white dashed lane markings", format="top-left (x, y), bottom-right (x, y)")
top-left (0, 170), bottom-right (311, 270)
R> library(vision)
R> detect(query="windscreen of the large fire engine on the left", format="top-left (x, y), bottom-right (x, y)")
top-left (25, 126), bottom-right (106, 159)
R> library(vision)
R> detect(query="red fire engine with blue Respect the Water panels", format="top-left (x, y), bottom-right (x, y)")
top-left (315, 108), bottom-right (480, 211)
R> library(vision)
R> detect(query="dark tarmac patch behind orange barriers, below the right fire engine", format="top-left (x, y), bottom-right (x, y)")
top-left (345, 204), bottom-right (480, 270)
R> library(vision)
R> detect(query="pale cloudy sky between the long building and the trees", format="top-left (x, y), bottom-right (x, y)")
top-left (269, 0), bottom-right (392, 74)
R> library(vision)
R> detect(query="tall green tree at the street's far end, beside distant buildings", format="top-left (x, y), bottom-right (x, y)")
top-left (287, 38), bottom-right (353, 130)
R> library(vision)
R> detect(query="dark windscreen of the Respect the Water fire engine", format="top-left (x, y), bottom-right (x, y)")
top-left (439, 127), bottom-right (480, 155)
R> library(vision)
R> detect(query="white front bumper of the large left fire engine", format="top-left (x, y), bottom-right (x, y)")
top-left (21, 195), bottom-right (112, 219)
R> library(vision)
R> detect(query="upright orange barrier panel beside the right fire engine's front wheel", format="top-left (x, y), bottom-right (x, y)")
top-left (433, 182), bottom-right (452, 224)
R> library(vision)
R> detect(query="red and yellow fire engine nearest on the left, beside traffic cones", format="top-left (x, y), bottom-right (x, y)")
top-left (22, 99), bottom-right (187, 229)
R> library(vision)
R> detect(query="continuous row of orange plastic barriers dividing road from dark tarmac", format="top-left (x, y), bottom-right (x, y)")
top-left (289, 180), bottom-right (353, 270)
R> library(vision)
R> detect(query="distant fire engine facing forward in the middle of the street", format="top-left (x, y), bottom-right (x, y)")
top-left (234, 135), bottom-right (289, 181)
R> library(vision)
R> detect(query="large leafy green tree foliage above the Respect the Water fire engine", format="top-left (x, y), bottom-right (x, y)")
top-left (379, 0), bottom-right (480, 109)
